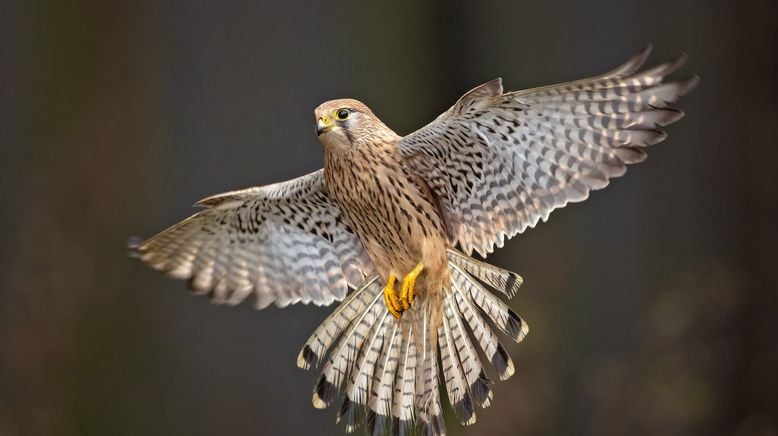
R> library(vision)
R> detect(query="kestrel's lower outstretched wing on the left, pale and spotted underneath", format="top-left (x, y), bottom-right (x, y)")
top-left (130, 170), bottom-right (372, 309)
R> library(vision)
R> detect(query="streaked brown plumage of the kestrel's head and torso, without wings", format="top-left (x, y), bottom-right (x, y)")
top-left (315, 99), bottom-right (449, 304)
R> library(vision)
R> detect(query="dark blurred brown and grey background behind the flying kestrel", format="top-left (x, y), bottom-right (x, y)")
top-left (0, 0), bottom-right (778, 436)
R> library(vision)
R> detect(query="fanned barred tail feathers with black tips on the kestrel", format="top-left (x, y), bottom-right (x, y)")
top-left (297, 250), bottom-right (528, 435)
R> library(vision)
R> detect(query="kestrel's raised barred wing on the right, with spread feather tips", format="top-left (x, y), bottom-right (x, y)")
top-left (399, 46), bottom-right (698, 255)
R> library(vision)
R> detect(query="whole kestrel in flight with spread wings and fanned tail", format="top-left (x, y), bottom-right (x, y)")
top-left (129, 45), bottom-right (699, 435)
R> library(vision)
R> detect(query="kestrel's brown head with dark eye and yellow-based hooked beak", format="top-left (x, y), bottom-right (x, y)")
top-left (314, 98), bottom-right (397, 152)
